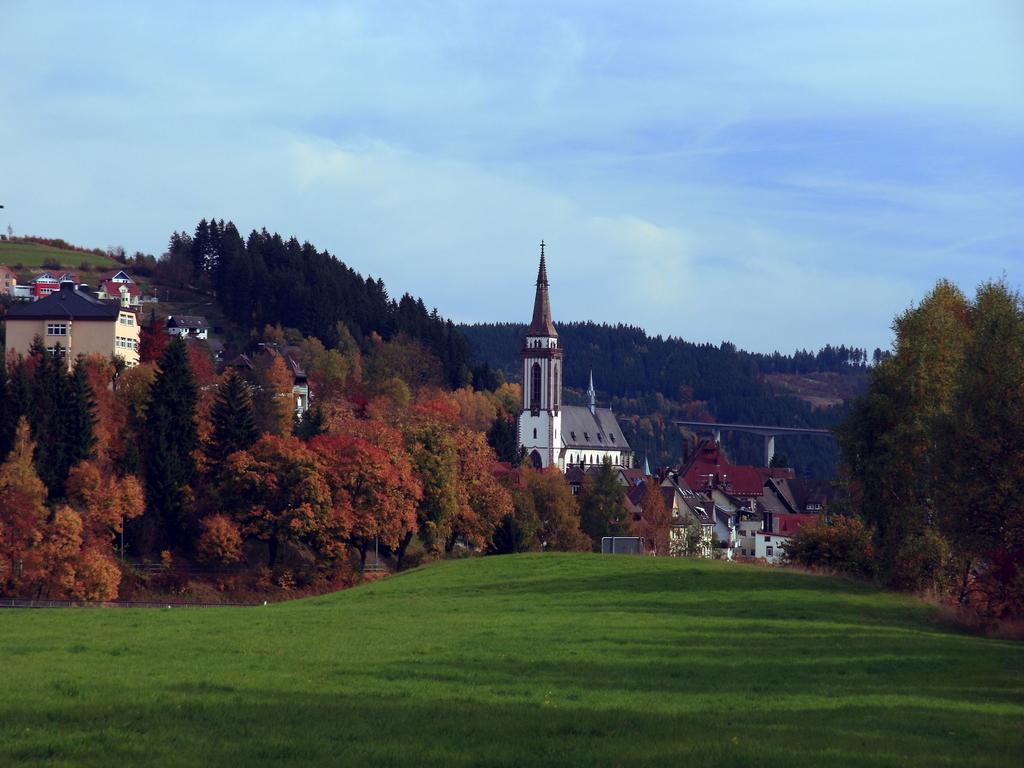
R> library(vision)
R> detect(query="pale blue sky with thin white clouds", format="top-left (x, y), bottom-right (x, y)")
top-left (0, 0), bottom-right (1024, 351)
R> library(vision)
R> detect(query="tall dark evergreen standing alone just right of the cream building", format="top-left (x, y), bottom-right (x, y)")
top-left (142, 339), bottom-right (199, 549)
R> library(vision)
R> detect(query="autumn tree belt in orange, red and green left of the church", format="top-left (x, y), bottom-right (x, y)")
top-left (0, 321), bottom-right (634, 599)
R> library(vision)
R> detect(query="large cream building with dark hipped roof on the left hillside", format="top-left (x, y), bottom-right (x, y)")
top-left (4, 281), bottom-right (139, 367)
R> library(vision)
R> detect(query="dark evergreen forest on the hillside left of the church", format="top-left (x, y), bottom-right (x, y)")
top-left (158, 219), bottom-right (472, 387)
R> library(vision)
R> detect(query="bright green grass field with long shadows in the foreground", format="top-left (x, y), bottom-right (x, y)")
top-left (0, 555), bottom-right (1024, 767)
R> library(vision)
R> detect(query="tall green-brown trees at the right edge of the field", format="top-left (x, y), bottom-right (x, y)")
top-left (791, 281), bottom-right (1024, 621)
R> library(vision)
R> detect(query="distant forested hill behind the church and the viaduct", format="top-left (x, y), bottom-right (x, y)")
top-left (459, 323), bottom-right (868, 477)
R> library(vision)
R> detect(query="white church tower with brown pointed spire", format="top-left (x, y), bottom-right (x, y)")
top-left (519, 241), bottom-right (562, 468)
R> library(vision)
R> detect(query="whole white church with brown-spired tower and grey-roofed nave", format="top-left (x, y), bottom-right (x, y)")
top-left (518, 242), bottom-right (633, 472)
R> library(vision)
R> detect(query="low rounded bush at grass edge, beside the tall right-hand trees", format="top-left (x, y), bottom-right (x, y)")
top-left (785, 516), bottom-right (874, 578)
